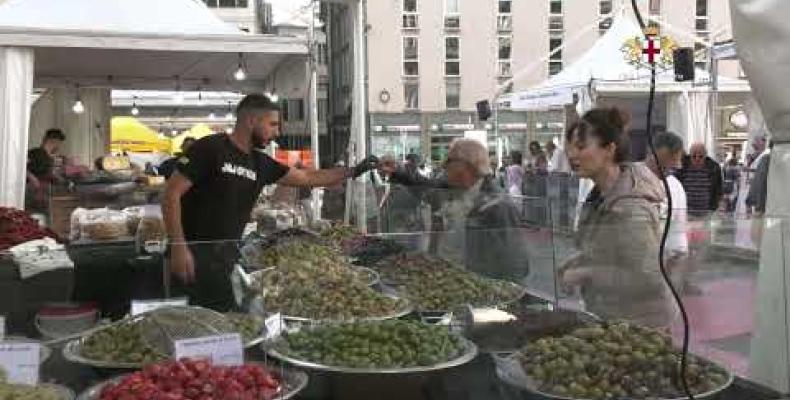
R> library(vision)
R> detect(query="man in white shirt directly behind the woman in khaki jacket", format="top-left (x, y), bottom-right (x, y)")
top-left (645, 132), bottom-right (689, 287)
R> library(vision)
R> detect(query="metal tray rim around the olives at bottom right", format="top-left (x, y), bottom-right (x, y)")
top-left (493, 353), bottom-right (735, 400)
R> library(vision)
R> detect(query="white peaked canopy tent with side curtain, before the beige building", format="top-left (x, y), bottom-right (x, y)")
top-left (497, 15), bottom-right (750, 154)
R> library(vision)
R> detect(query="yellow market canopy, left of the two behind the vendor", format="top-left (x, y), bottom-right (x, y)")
top-left (110, 117), bottom-right (170, 153)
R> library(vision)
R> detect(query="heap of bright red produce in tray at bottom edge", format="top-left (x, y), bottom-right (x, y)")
top-left (100, 359), bottom-right (282, 400)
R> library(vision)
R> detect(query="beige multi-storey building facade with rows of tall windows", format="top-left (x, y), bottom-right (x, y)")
top-left (324, 0), bottom-right (739, 160)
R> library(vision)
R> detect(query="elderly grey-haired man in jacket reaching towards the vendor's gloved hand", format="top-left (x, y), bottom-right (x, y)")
top-left (380, 139), bottom-right (529, 282)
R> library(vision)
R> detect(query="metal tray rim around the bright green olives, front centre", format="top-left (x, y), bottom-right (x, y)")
top-left (264, 336), bottom-right (477, 374)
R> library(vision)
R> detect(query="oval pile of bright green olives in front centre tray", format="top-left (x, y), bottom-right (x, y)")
top-left (280, 320), bottom-right (464, 369)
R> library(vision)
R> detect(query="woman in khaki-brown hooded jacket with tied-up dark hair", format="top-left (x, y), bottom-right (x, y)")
top-left (561, 108), bottom-right (672, 327)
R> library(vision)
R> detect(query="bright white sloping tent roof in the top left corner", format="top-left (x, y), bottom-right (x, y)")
top-left (0, 0), bottom-right (239, 35)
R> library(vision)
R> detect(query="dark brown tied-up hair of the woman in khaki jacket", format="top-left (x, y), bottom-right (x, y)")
top-left (565, 107), bottom-right (631, 163)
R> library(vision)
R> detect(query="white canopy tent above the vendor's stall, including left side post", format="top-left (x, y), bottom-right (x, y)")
top-left (0, 0), bottom-right (308, 207)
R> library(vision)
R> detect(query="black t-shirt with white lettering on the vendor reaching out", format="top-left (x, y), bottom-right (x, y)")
top-left (177, 134), bottom-right (289, 241)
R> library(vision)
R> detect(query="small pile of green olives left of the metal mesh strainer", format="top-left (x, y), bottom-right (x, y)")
top-left (81, 320), bottom-right (167, 365)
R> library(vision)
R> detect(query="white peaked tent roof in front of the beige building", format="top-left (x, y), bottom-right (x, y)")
top-left (498, 15), bottom-right (749, 109)
